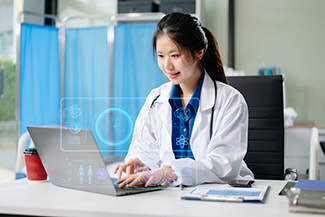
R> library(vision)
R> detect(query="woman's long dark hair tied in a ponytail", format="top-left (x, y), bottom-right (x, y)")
top-left (152, 12), bottom-right (228, 84)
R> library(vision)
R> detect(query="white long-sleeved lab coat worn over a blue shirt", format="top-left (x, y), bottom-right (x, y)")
top-left (126, 71), bottom-right (254, 185)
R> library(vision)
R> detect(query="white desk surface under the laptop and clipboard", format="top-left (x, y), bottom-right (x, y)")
top-left (0, 179), bottom-right (315, 217)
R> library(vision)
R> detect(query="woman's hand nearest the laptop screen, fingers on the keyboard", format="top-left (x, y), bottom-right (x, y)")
top-left (114, 158), bottom-right (146, 179)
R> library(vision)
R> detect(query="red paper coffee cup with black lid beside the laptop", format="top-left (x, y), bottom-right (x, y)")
top-left (24, 148), bottom-right (47, 181)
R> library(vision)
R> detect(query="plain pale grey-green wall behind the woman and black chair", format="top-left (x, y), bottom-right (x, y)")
top-left (203, 0), bottom-right (325, 125)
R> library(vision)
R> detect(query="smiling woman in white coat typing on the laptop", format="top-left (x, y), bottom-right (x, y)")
top-left (115, 13), bottom-right (253, 188)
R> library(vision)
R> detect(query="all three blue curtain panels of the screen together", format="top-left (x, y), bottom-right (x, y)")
top-left (21, 24), bottom-right (165, 156)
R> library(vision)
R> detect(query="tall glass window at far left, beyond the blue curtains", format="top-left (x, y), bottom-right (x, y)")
top-left (0, 0), bottom-right (16, 184)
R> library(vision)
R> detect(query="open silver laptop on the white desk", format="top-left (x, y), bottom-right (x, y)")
top-left (27, 126), bottom-right (162, 196)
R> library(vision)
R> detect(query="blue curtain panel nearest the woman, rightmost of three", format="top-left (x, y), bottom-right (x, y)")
top-left (113, 24), bottom-right (165, 156)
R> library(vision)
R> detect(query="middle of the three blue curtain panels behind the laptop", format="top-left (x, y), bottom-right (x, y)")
top-left (61, 26), bottom-right (110, 153)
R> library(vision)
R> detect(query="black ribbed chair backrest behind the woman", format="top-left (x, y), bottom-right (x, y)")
top-left (228, 75), bottom-right (284, 180)
